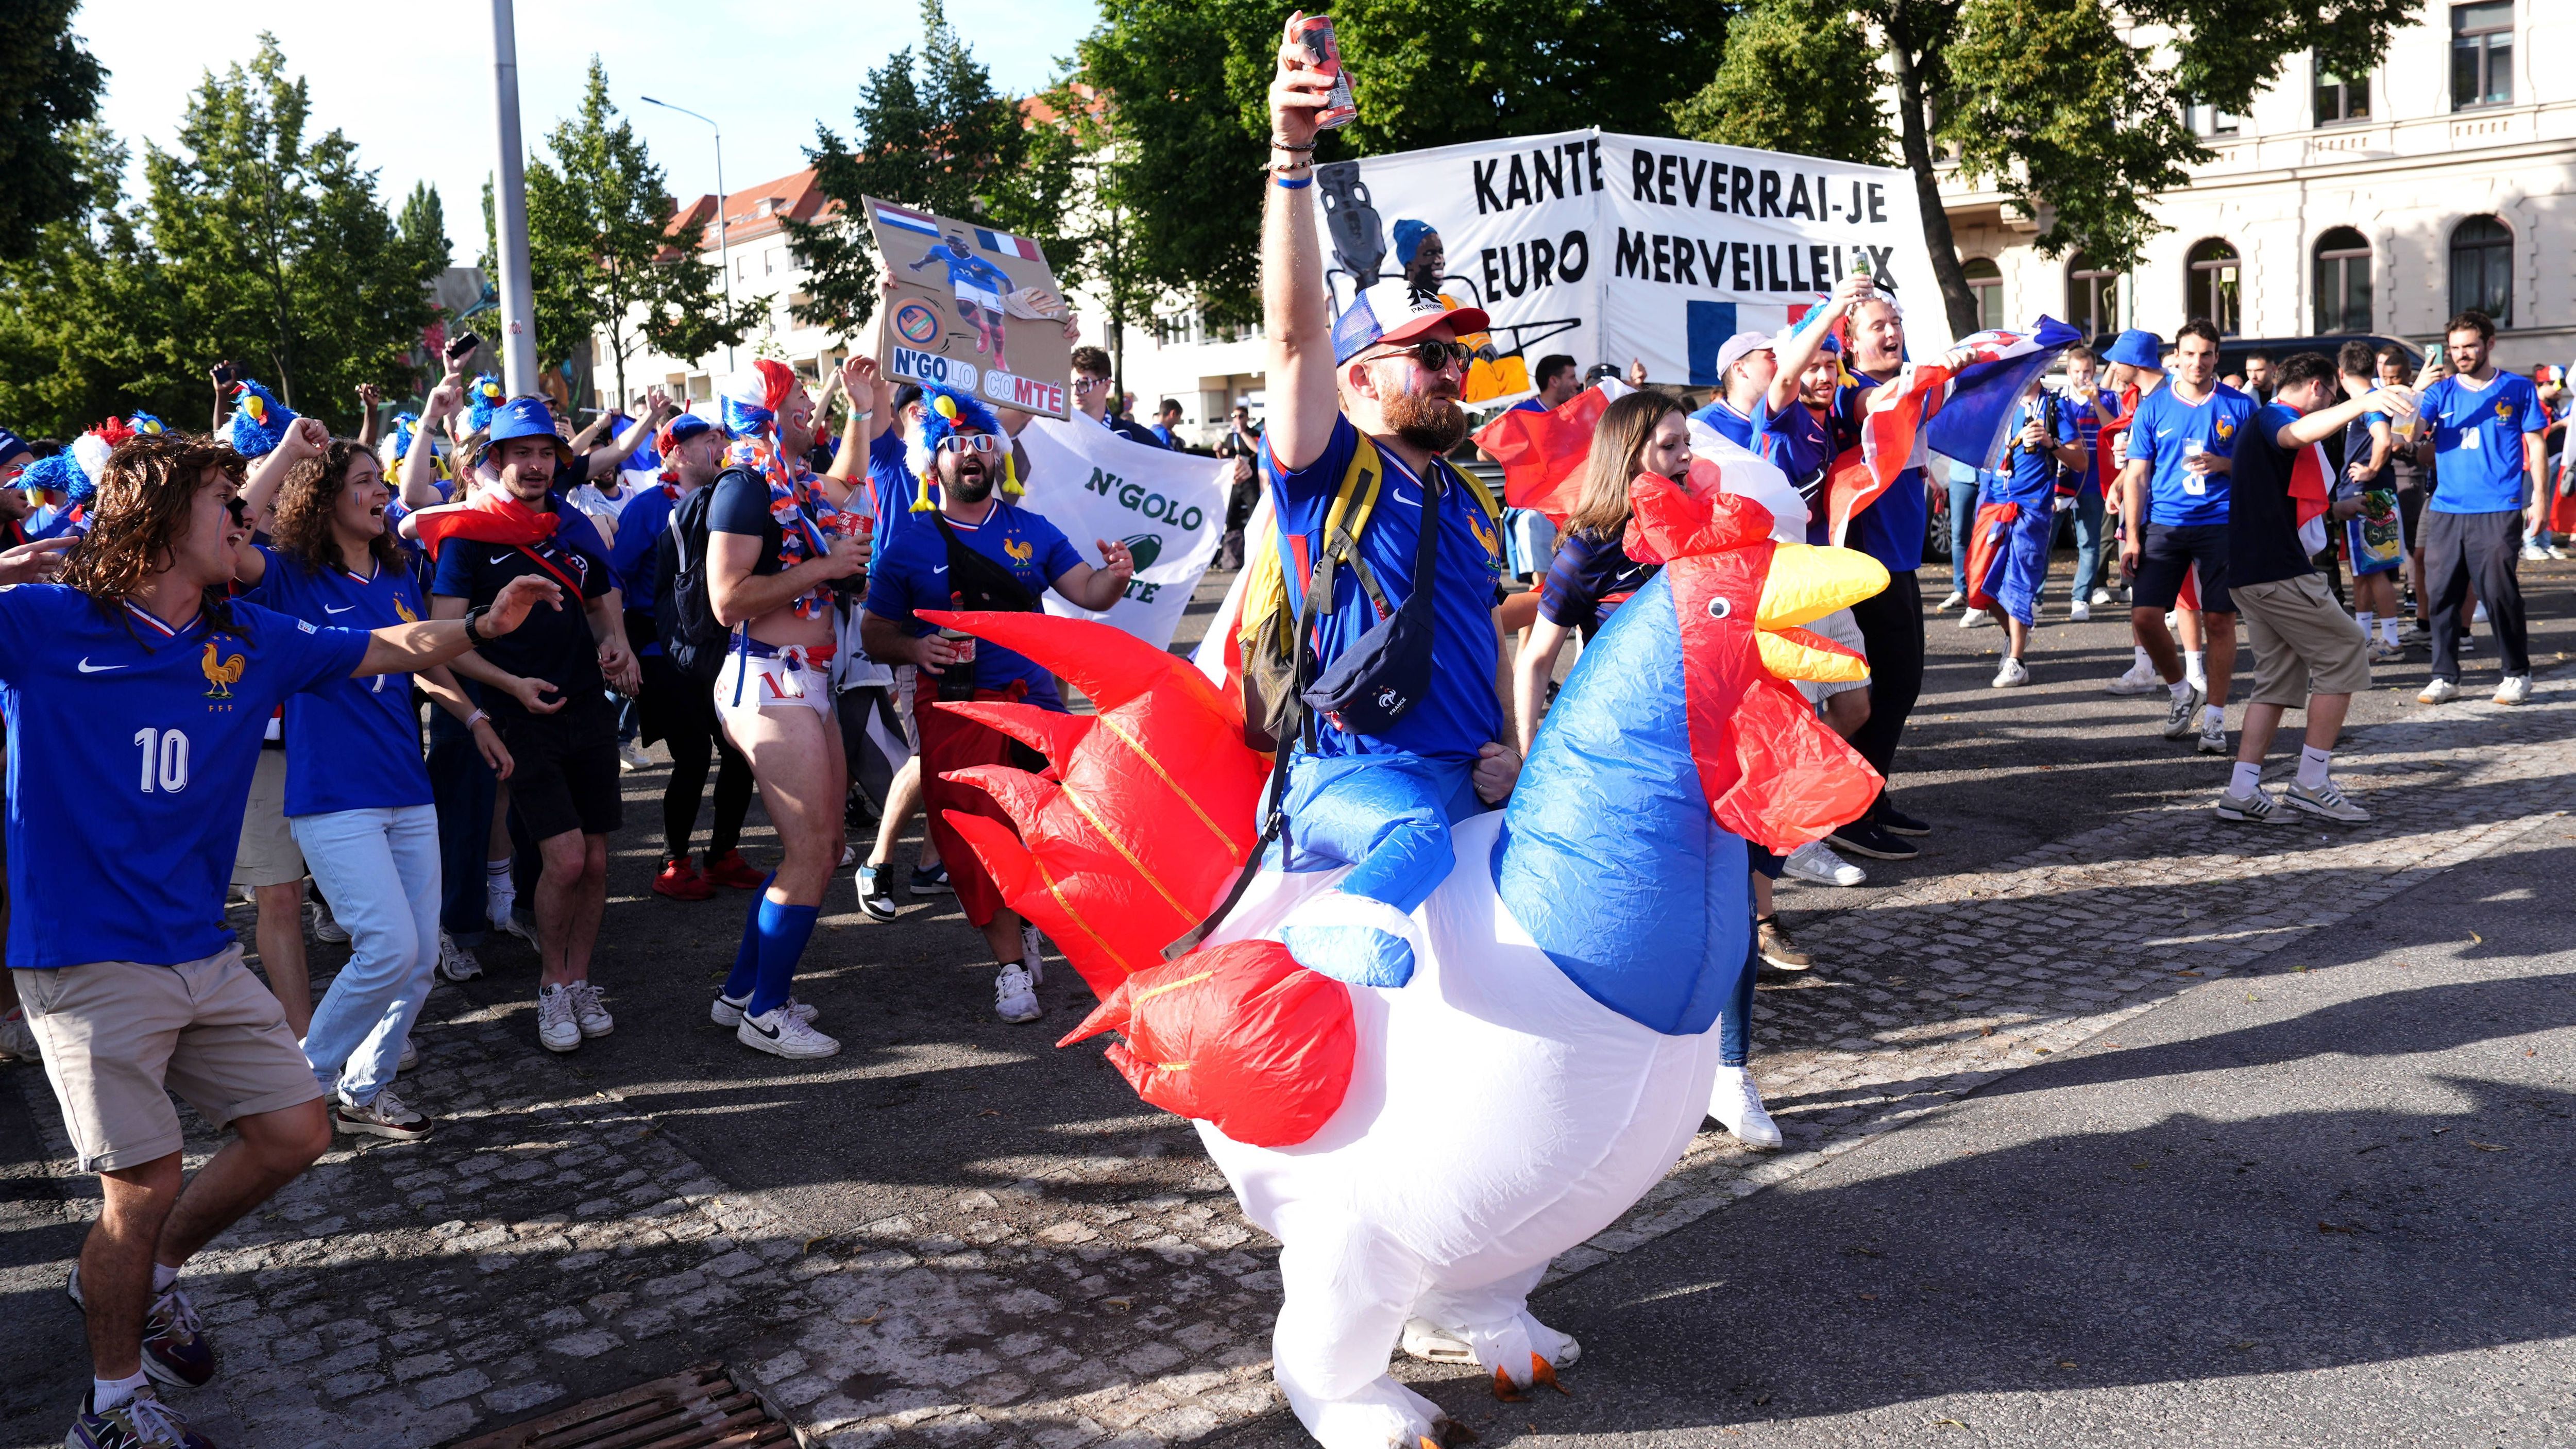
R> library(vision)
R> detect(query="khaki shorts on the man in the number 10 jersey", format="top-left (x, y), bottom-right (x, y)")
top-left (13, 946), bottom-right (322, 1173)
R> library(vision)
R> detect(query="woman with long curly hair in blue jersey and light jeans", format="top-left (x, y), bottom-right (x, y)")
top-left (234, 423), bottom-right (510, 1142)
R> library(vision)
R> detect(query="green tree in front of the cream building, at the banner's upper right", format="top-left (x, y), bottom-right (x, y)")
top-left (1674, 0), bottom-right (2421, 332)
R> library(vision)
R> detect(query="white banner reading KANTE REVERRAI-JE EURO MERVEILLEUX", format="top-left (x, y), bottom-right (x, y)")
top-left (1314, 129), bottom-right (1950, 394)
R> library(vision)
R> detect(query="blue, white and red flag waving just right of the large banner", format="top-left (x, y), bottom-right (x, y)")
top-left (1826, 317), bottom-right (2081, 544)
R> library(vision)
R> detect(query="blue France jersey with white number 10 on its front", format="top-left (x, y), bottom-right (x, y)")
top-left (0, 583), bottom-right (366, 969)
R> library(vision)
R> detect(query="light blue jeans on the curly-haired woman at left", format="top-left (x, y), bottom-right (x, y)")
top-left (286, 804), bottom-right (438, 1106)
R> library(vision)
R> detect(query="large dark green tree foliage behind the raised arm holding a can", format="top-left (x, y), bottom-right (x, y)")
top-left (1077, 0), bottom-right (1731, 322)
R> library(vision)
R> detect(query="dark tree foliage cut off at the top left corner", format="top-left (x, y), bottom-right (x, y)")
top-left (0, 0), bottom-right (108, 258)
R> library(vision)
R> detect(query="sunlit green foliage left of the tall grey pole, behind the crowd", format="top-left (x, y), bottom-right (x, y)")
top-left (0, 36), bottom-right (448, 433)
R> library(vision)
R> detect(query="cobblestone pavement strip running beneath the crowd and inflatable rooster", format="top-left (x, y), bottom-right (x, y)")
top-left (0, 657), bottom-right (2576, 1449)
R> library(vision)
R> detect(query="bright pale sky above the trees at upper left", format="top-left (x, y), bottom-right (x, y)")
top-left (72, 0), bottom-right (1095, 265)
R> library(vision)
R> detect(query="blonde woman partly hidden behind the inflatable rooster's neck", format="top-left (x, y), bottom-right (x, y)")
top-left (1512, 392), bottom-right (1806, 1148)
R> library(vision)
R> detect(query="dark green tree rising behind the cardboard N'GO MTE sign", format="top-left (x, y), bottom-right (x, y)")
top-left (783, 0), bottom-right (1082, 332)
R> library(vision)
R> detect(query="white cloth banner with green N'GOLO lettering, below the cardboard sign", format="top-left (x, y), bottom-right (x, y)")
top-left (1020, 418), bottom-right (1234, 650)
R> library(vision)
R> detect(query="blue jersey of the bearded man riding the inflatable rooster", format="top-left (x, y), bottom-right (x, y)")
top-left (1260, 418), bottom-right (1502, 761)
